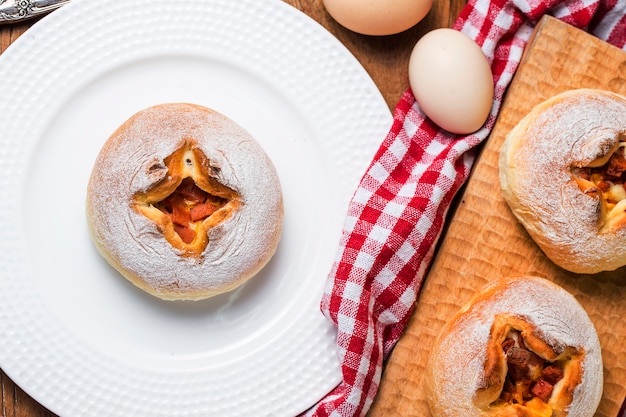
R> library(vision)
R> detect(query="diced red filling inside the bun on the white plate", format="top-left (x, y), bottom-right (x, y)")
top-left (154, 177), bottom-right (227, 244)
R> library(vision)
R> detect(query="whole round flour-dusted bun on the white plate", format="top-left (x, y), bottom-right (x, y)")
top-left (86, 103), bottom-right (283, 300)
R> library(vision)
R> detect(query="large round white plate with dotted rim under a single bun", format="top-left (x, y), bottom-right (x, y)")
top-left (0, 0), bottom-right (391, 417)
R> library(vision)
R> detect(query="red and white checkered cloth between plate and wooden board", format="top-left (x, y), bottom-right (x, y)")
top-left (306, 0), bottom-right (626, 417)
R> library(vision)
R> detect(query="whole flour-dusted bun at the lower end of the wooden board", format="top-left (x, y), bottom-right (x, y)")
top-left (424, 277), bottom-right (603, 417)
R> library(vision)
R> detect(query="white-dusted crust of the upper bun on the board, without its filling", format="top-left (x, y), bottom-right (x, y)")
top-left (500, 89), bottom-right (626, 273)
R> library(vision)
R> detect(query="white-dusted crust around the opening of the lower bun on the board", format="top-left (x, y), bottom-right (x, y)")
top-left (427, 277), bottom-right (603, 417)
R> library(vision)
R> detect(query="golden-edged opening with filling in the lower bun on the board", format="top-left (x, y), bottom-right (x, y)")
top-left (475, 315), bottom-right (585, 417)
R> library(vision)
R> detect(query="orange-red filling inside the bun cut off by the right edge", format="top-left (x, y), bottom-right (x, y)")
top-left (572, 141), bottom-right (626, 210)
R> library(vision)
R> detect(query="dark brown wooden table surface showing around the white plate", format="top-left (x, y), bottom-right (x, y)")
top-left (0, 0), bottom-right (465, 417)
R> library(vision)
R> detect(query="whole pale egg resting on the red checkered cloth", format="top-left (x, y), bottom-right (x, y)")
top-left (409, 28), bottom-right (493, 134)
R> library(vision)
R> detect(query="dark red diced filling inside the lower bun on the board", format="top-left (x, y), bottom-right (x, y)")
top-left (496, 331), bottom-right (563, 405)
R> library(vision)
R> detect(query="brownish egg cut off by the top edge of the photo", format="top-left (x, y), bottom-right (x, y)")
top-left (323, 0), bottom-right (433, 36)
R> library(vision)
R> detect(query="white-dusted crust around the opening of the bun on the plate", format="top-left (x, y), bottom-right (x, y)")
top-left (87, 103), bottom-right (283, 298)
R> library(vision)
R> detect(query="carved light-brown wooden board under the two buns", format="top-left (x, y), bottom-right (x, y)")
top-left (368, 17), bottom-right (626, 417)
